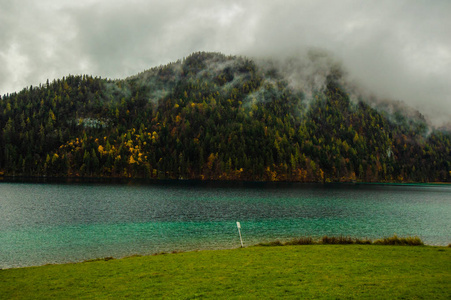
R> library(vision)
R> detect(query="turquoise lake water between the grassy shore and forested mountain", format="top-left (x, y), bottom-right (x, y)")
top-left (0, 182), bottom-right (451, 268)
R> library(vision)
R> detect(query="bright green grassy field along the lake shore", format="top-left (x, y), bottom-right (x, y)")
top-left (0, 245), bottom-right (451, 299)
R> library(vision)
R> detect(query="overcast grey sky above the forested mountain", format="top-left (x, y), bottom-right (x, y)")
top-left (0, 0), bottom-right (451, 124)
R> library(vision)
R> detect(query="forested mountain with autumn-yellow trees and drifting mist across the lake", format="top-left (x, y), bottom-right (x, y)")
top-left (0, 52), bottom-right (451, 182)
